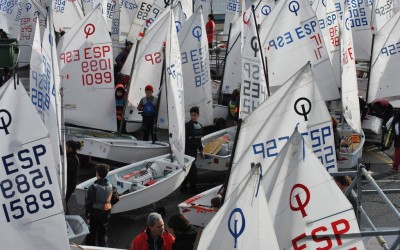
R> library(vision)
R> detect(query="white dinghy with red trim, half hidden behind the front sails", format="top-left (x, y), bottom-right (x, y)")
top-left (178, 185), bottom-right (222, 227)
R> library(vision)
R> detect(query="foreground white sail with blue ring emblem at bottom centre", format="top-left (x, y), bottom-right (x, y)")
top-left (197, 165), bottom-right (279, 250)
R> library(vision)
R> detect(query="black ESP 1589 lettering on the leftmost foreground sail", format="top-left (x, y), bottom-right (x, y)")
top-left (0, 145), bottom-right (55, 222)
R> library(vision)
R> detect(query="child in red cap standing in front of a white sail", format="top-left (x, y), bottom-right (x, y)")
top-left (137, 84), bottom-right (157, 142)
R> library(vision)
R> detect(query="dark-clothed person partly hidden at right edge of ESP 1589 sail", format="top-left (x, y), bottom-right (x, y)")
top-left (65, 140), bottom-right (82, 204)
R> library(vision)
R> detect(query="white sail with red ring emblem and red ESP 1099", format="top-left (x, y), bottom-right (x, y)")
top-left (57, 5), bottom-right (117, 131)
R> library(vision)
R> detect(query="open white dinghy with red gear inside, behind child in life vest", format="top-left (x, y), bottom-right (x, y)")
top-left (75, 154), bottom-right (194, 213)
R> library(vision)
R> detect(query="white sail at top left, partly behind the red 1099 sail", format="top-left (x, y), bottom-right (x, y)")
top-left (51, 0), bottom-right (84, 32)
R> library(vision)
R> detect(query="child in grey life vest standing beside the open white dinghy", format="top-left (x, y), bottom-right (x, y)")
top-left (85, 163), bottom-right (113, 247)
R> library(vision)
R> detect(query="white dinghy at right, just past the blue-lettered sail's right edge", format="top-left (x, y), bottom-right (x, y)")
top-left (337, 127), bottom-right (365, 169)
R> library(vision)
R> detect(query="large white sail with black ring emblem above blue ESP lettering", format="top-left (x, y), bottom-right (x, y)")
top-left (227, 64), bottom-right (337, 199)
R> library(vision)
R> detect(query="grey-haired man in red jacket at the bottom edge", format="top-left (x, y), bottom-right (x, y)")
top-left (129, 213), bottom-right (175, 250)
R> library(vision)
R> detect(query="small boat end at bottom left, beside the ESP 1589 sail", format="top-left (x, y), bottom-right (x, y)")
top-left (65, 215), bottom-right (89, 244)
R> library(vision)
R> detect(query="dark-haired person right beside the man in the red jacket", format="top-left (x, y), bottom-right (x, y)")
top-left (167, 214), bottom-right (197, 250)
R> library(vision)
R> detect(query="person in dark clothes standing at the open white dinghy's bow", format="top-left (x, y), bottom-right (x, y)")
top-left (179, 107), bottom-right (204, 194)
